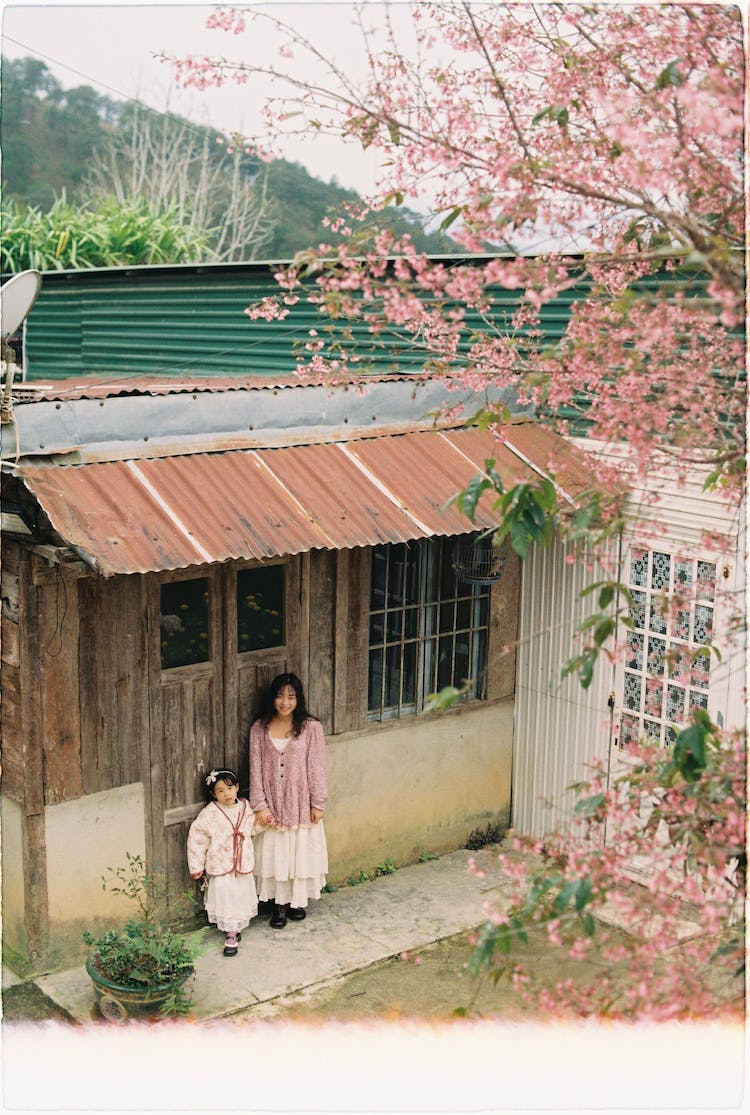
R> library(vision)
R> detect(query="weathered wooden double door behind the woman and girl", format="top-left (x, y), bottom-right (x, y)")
top-left (148, 560), bottom-right (301, 920)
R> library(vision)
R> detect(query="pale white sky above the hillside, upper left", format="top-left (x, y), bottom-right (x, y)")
top-left (2, 0), bottom-right (392, 193)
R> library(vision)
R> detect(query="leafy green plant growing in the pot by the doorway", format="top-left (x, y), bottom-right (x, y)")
top-left (82, 852), bottom-right (198, 1015)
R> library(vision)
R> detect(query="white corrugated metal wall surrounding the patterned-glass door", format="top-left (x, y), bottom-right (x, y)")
top-left (512, 442), bottom-right (747, 836)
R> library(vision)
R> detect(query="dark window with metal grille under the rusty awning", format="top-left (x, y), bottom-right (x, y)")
top-left (368, 537), bottom-right (489, 720)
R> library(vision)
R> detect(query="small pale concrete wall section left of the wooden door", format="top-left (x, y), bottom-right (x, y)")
top-left (45, 783), bottom-right (146, 951)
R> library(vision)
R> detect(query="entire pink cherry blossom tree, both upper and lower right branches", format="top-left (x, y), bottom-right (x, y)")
top-left (169, 0), bottom-right (746, 1018)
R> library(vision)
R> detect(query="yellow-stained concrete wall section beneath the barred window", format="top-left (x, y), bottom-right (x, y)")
top-left (325, 701), bottom-right (514, 884)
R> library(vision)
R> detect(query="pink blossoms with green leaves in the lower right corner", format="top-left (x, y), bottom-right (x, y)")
top-left (469, 708), bottom-right (747, 1014)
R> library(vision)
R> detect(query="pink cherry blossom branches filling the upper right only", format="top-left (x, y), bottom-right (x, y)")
top-left (169, 2), bottom-right (744, 493)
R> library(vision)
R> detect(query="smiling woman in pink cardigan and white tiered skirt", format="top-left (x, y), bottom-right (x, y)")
top-left (250, 673), bottom-right (328, 929)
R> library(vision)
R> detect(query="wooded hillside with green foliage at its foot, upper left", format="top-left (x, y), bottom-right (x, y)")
top-left (0, 58), bottom-right (456, 271)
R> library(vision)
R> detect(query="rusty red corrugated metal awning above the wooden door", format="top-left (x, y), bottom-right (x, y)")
top-left (19, 421), bottom-right (593, 576)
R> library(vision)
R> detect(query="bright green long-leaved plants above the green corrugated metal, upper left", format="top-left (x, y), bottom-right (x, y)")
top-left (0, 195), bottom-right (205, 272)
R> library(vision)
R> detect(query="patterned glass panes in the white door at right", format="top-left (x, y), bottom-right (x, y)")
top-left (620, 550), bottom-right (717, 746)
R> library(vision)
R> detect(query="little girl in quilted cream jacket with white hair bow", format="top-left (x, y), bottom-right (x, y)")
top-left (187, 770), bottom-right (273, 957)
